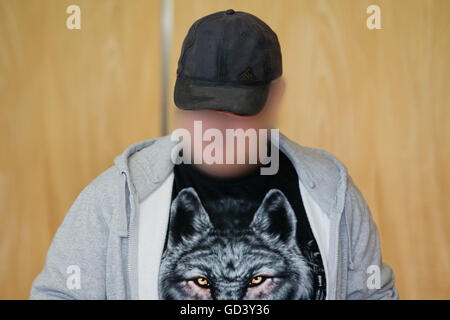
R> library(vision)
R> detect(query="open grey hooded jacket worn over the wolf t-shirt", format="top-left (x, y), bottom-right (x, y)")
top-left (30, 135), bottom-right (398, 299)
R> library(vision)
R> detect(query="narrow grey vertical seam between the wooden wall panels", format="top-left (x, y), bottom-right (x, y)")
top-left (161, 0), bottom-right (173, 136)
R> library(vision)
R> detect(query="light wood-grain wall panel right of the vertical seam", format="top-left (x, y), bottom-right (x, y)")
top-left (170, 0), bottom-right (450, 299)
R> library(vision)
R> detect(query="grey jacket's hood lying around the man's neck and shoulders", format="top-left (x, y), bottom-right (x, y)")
top-left (114, 133), bottom-right (347, 215)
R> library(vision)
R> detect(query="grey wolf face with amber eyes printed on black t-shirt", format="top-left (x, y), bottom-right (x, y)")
top-left (159, 188), bottom-right (313, 300)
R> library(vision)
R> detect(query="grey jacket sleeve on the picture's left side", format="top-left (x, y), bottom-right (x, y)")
top-left (30, 183), bottom-right (109, 299)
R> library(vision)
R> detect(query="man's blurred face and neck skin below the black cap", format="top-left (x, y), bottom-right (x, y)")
top-left (177, 78), bottom-right (285, 177)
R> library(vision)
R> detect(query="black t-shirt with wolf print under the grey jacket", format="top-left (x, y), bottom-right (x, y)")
top-left (159, 152), bottom-right (326, 300)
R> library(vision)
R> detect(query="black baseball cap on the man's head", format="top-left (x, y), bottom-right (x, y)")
top-left (174, 9), bottom-right (282, 115)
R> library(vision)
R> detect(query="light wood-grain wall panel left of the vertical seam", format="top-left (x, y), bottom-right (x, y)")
top-left (0, 0), bottom-right (161, 299)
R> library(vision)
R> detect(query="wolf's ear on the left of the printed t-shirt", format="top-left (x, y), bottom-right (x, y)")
top-left (169, 188), bottom-right (213, 245)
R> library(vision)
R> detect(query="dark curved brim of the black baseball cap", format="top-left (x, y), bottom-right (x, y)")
top-left (174, 78), bottom-right (270, 115)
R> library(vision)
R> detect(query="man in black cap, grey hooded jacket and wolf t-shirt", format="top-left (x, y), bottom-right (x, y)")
top-left (31, 9), bottom-right (398, 299)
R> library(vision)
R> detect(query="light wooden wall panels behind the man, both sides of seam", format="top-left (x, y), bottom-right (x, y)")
top-left (0, 0), bottom-right (450, 299)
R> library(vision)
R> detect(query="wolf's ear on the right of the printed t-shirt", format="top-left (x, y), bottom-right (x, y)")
top-left (250, 189), bottom-right (297, 243)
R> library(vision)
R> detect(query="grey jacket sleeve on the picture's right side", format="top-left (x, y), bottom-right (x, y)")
top-left (344, 177), bottom-right (398, 300)
